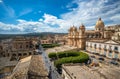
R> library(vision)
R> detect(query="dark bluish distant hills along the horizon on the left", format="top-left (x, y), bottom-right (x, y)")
top-left (0, 32), bottom-right (67, 40)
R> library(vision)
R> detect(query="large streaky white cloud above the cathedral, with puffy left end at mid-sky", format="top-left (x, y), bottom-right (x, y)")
top-left (43, 0), bottom-right (120, 32)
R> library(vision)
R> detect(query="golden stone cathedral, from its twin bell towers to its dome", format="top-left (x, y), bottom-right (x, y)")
top-left (68, 18), bottom-right (104, 49)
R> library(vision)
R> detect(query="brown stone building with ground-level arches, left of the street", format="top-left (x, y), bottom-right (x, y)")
top-left (0, 37), bottom-right (38, 58)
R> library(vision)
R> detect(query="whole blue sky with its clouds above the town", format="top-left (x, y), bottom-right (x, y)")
top-left (0, 0), bottom-right (120, 34)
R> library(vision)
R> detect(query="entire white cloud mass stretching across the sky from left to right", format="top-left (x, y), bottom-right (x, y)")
top-left (0, 0), bottom-right (120, 32)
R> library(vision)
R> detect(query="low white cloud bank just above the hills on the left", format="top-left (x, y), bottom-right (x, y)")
top-left (0, 19), bottom-right (64, 33)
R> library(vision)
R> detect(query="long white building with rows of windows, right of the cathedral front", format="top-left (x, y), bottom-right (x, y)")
top-left (86, 40), bottom-right (120, 59)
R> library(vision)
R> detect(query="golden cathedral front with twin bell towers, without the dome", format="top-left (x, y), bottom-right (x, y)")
top-left (68, 25), bottom-right (86, 49)
